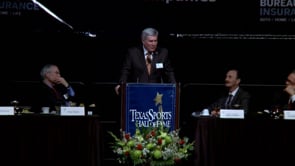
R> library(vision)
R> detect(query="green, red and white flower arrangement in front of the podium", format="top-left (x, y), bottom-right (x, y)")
top-left (109, 126), bottom-right (194, 166)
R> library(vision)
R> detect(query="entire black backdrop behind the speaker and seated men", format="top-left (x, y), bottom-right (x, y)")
top-left (0, 0), bottom-right (295, 84)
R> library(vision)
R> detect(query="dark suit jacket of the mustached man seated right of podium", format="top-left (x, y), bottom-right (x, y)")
top-left (208, 87), bottom-right (251, 114)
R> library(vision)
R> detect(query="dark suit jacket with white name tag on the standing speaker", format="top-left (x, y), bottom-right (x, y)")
top-left (119, 47), bottom-right (176, 83)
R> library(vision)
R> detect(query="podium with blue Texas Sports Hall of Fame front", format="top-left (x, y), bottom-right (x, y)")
top-left (121, 83), bottom-right (179, 135)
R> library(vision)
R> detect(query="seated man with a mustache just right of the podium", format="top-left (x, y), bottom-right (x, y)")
top-left (208, 69), bottom-right (250, 116)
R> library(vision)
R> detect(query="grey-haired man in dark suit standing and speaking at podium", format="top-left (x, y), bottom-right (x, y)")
top-left (115, 28), bottom-right (176, 94)
